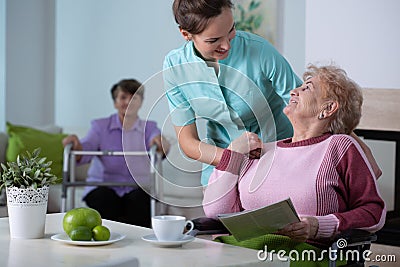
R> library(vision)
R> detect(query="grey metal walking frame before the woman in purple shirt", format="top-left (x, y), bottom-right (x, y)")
top-left (61, 143), bottom-right (163, 216)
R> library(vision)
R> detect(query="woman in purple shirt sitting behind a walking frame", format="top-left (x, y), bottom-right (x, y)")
top-left (63, 79), bottom-right (169, 227)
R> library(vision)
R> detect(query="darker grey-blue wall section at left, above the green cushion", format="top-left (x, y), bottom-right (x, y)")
top-left (5, 0), bottom-right (55, 126)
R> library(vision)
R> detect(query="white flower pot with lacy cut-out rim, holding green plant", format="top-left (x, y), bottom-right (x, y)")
top-left (6, 187), bottom-right (49, 239)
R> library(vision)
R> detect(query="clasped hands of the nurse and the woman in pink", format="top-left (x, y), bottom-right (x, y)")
top-left (228, 132), bottom-right (263, 155)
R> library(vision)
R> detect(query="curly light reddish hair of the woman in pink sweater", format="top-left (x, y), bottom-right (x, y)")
top-left (303, 64), bottom-right (363, 134)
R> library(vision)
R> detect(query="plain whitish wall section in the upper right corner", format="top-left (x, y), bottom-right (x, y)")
top-left (305, 0), bottom-right (400, 88)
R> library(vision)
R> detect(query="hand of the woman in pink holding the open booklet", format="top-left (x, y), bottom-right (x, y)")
top-left (277, 216), bottom-right (318, 242)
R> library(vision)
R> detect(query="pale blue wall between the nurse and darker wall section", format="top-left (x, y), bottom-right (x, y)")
top-left (55, 0), bottom-right (183, 138)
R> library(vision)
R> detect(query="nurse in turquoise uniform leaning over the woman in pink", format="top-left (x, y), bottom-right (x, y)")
top-left (163, 0), bottom-right (302, 185)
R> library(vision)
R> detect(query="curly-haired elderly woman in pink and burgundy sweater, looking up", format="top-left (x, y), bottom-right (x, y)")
top-left (203, 65), bottom-right (386, 250)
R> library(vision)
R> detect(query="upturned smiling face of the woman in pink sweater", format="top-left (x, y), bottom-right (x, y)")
top-left (284, 77), bottom-right (323, 119)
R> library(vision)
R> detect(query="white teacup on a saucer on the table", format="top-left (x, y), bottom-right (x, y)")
top-left (151, 215), bottom-right (194, 241)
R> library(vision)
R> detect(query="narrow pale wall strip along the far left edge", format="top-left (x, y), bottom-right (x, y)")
top-left (0, 0), bottom-right (6, 131)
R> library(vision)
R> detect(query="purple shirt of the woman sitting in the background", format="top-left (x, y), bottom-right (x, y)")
top-left (79, 114), bottom-right (161, 197)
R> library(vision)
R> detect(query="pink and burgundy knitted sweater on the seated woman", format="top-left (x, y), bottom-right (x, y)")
top-left (203, 134), bottom-right (386, 243)
